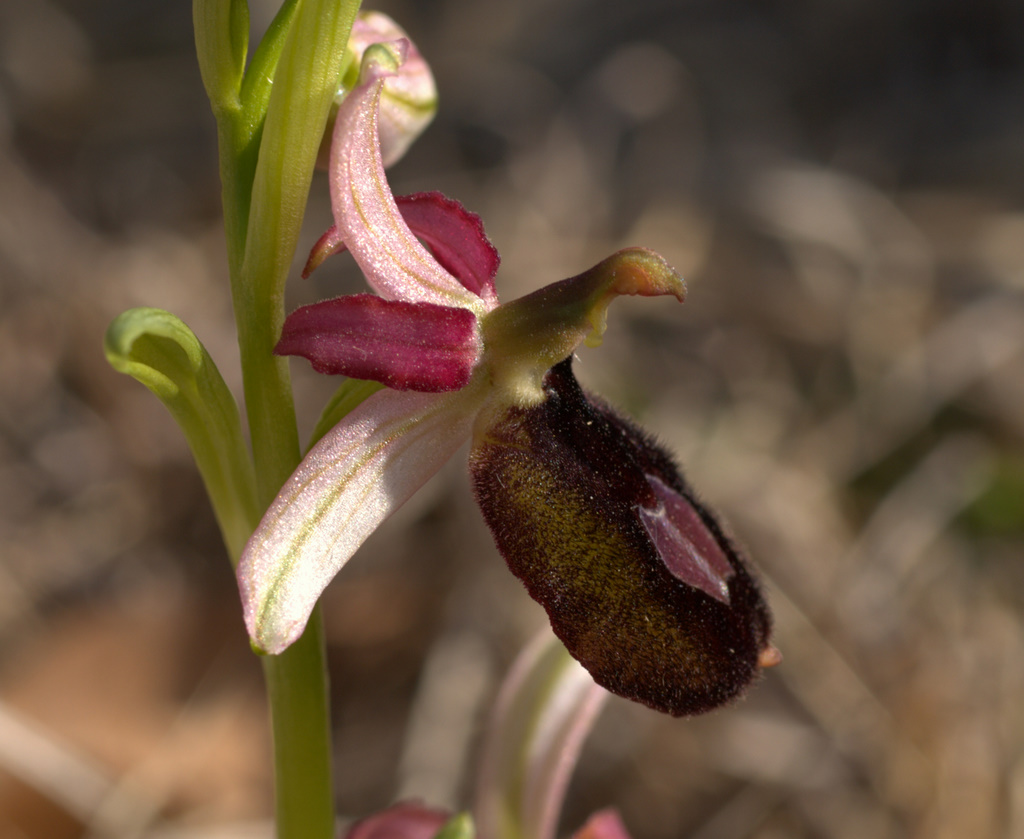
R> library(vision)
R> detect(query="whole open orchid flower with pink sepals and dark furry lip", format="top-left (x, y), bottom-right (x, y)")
top-left (238, 39), bottom-right (777, 715)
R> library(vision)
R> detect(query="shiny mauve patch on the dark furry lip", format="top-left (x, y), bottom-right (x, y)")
top-left (640, 475), bottom-right (735, 605)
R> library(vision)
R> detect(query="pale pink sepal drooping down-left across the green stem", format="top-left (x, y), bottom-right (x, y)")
top-left (238, 387), bottom-right (480, 653)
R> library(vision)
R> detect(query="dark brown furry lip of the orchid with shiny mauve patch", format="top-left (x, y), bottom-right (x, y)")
top-left (470, 359), bottom-right (777, 716)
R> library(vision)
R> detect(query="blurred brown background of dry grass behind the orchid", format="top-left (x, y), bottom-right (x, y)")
top-left (0, 0), bottom-right (1024, 839)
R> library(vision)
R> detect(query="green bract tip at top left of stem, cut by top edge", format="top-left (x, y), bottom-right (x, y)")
top-left (193, 0), bottom-right (249, 114)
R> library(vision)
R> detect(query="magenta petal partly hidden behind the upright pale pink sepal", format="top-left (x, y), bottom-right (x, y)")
top-left (395, 192), bottom-right (501, 299)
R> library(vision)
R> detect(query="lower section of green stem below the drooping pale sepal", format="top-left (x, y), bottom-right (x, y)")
top-left (263, 606), bottom-right (334, 839)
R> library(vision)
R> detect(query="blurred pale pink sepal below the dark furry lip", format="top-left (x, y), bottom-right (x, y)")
top-left (473, 629), bottom-right (608, 839)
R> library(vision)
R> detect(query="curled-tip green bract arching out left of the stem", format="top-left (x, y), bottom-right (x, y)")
top-left (103, 308), bottom-right (259, 562)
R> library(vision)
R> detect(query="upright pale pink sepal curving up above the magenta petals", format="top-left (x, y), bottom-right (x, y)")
top-left (330, 41), bottom-right (493, 314)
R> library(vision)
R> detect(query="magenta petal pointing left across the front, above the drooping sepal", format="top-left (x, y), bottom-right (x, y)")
top-left (274, 294), bottom-right (480, 393)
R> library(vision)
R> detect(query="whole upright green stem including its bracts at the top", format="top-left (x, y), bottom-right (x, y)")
top-left (194, 0), bottom-right (359, 839)
